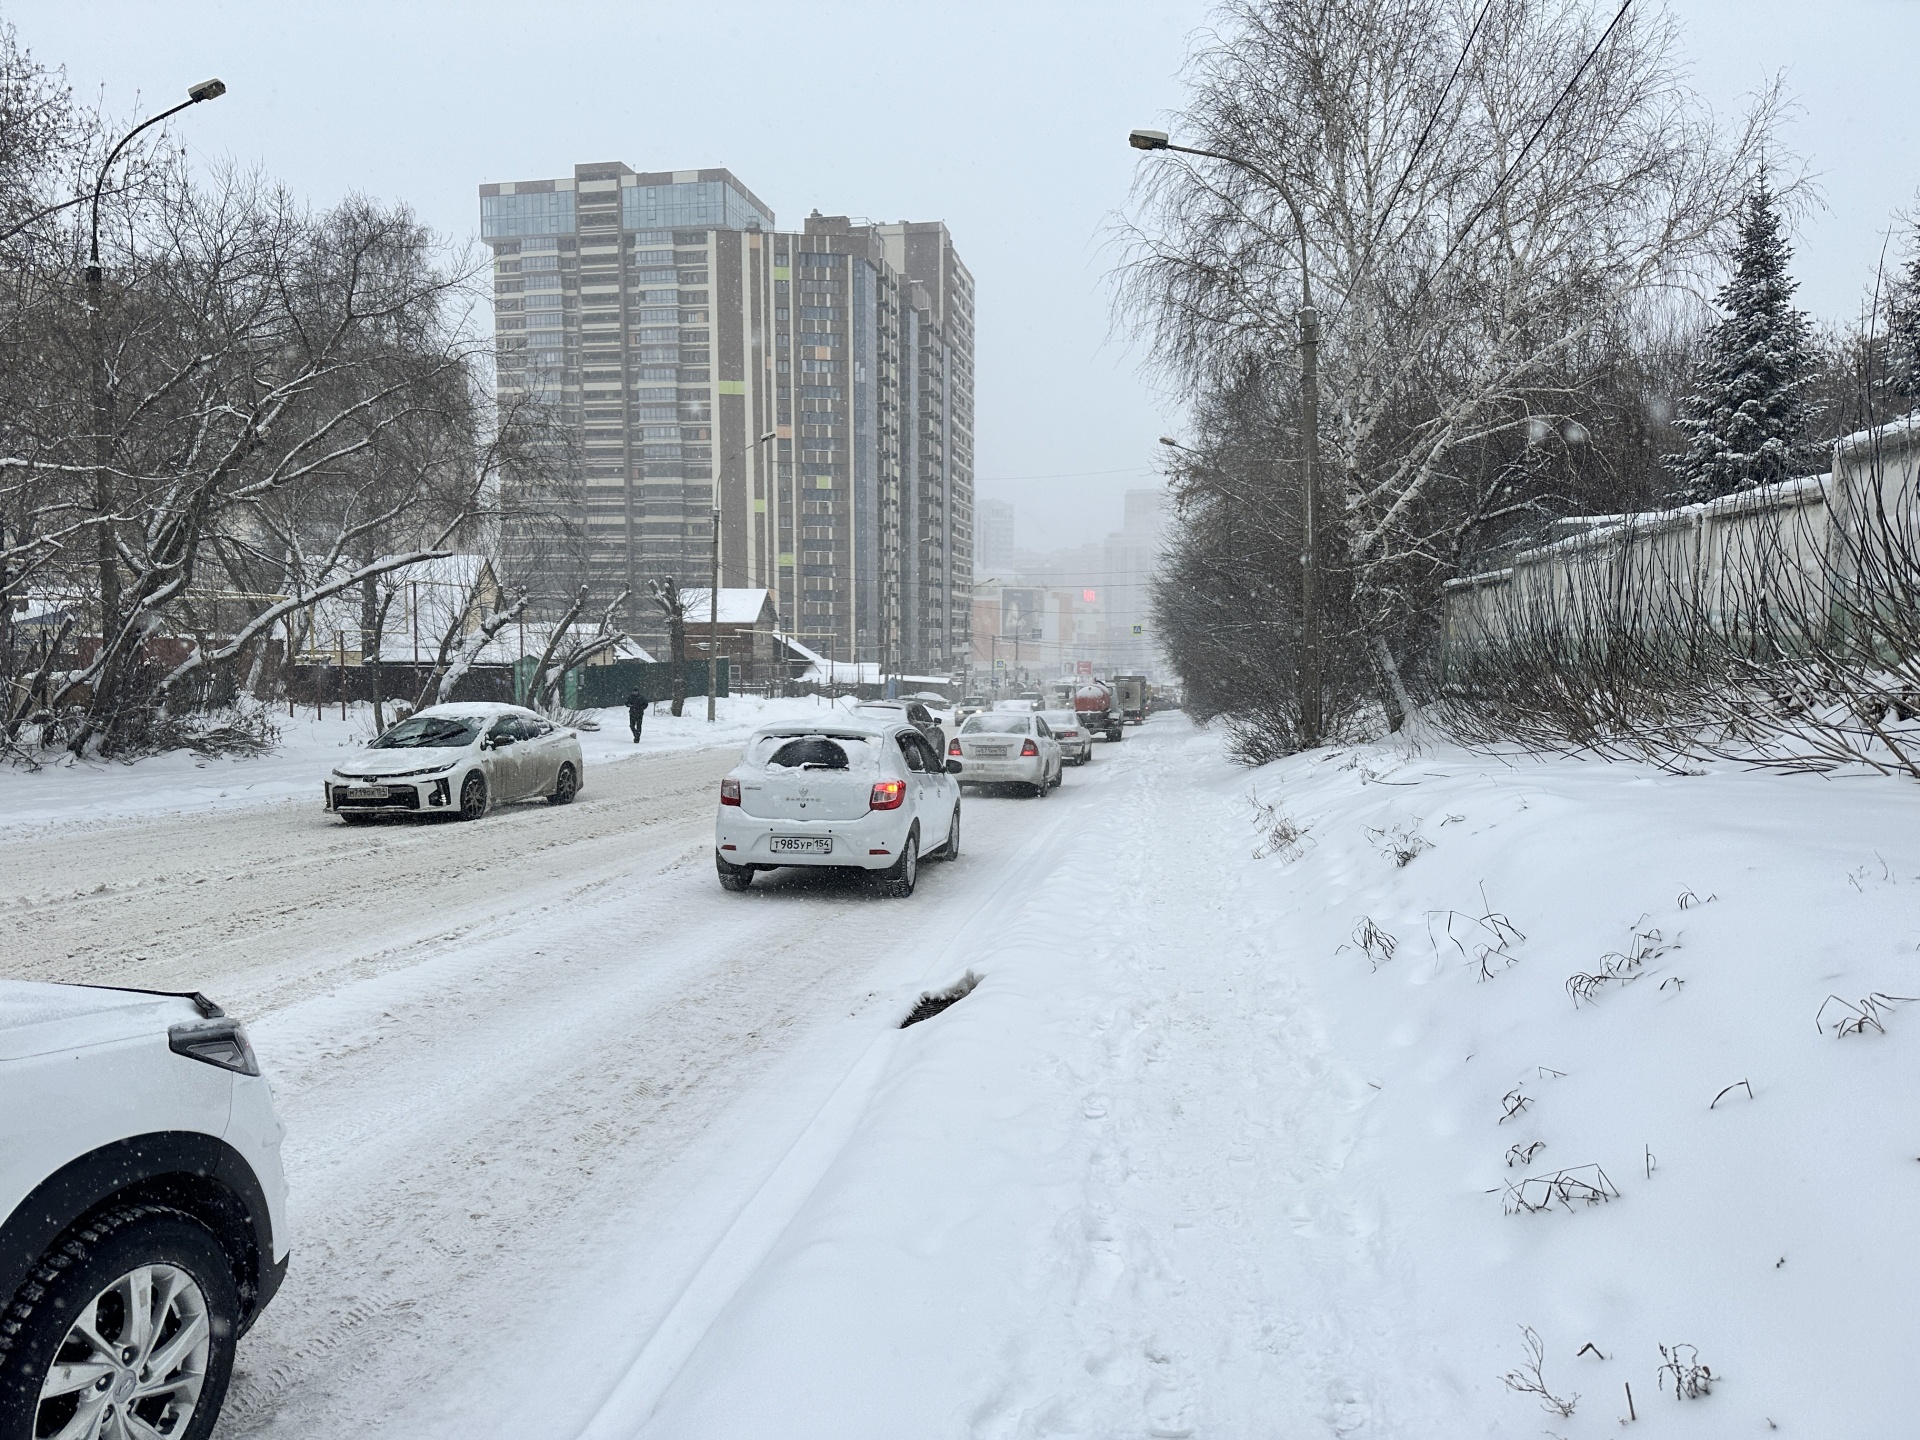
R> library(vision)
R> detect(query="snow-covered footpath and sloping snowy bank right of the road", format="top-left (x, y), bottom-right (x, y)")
top-left (606, 718), bottom-right (1920, 1440)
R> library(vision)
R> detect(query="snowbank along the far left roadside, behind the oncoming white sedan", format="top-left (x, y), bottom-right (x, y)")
top-left (0, 695), bottom-right (844, 826)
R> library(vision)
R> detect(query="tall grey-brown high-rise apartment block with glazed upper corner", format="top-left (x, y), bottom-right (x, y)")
top-left (480, 163), bottom-right (973, 674)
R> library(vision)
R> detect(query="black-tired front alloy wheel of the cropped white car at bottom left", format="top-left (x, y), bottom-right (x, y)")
top-left (0, 1206), bottom-right (240, 1440)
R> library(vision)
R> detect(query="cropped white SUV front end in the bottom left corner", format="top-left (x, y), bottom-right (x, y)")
top-left (0, 981), bottom-right (288, 1440)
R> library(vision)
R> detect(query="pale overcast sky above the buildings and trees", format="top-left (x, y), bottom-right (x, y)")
top-left (22, 0), bottom-right (1920, 549)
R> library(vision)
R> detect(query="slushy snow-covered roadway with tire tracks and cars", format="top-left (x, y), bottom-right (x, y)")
top-left (0, 725), bottom-right (1154, 1440)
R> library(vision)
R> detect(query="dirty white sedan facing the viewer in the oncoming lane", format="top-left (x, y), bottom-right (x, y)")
top-left (323, 705), bottom-right (586, 824)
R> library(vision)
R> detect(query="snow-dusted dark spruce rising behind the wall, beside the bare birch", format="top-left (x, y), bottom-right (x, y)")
top-left (1667, 175), bottom-right (1818, 501)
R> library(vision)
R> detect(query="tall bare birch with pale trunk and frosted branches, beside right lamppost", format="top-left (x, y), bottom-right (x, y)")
top-left (1117, 0), bottom-right (1780, 744)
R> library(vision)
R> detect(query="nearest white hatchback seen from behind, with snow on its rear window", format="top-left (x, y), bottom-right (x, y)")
top-left (714, 718), bottom-right (960, 897)
